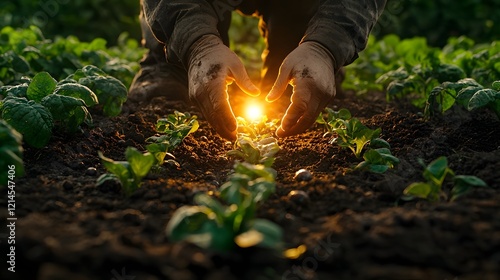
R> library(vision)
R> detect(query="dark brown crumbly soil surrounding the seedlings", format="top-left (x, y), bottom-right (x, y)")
top-left (0, 88), bottom-right (500, 280)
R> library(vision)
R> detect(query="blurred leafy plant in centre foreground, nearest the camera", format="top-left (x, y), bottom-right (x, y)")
top-left (167, 163), bottom-right (283, 251)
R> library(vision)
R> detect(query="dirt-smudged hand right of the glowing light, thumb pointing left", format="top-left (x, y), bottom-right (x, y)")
top-left (266, 41), bottom-right (335, 137)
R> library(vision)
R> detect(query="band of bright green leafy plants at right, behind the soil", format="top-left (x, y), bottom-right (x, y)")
top-left (343, 35), bottom-right (500, 118)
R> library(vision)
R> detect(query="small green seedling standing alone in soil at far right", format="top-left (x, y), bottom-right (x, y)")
top-left (403, 156), bottom-right (487, 201)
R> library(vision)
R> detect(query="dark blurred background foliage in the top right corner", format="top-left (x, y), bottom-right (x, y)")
top-left (373, 0), bottom-right (500, 46)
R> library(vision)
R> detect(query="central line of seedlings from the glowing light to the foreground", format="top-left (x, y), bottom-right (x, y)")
top-left (167, 117), bottom-right (283, 251)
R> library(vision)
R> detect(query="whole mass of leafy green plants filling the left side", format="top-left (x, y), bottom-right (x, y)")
top-left (0, 26), bottom-right (144, 186)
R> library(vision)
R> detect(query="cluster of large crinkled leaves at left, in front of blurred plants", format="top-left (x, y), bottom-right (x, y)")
top-left (0, 65), bottom-right (127, 148)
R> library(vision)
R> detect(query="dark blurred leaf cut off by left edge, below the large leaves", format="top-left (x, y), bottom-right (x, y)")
top-left (0, 120), bottom-right (24, 186)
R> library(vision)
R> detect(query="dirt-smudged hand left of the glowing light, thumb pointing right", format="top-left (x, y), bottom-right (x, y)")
top-left (188, 35), bottom-right (260, 140)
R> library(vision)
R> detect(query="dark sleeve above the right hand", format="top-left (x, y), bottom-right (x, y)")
top-left (302, 0), bottom-right (386, 69)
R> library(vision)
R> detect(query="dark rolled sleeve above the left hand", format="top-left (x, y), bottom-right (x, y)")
top-left (143, 0), bottom-right (220, 66)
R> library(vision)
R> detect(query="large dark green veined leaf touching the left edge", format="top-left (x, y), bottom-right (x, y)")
top-left (2, 96), bottom-right (54, 148)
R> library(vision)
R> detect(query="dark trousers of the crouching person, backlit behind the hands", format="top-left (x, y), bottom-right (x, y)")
top-left (141, 0), bottom-right (319, 92)
